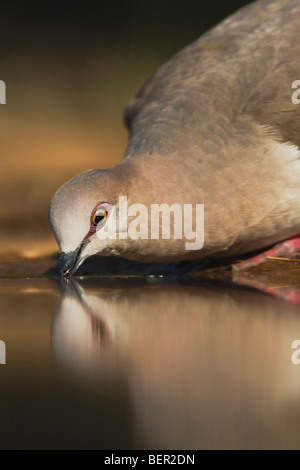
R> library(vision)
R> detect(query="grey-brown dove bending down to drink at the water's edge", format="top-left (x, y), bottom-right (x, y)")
top-left (50, 0), bottom-right (300, 274)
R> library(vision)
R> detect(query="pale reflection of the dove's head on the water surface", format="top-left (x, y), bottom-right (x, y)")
top-left (51, 279), bottom-right (127, 376)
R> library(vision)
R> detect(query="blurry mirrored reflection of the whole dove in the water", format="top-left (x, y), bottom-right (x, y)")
top-left (52, 282), bottom-right (300, 449)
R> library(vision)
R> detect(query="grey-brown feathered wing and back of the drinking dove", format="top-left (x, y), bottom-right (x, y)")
top-left (125, 0), bottom-right (300, 155)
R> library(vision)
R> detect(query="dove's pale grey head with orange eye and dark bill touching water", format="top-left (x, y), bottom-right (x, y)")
top-left (49, 170), bottom-right (125, 275)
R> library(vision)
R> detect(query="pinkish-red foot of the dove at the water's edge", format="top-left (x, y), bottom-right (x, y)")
top-left (232, 235), bottom-right (300, 271)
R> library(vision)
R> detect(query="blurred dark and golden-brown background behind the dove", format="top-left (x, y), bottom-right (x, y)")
top-left (0, 0), bottom-right (249, 261)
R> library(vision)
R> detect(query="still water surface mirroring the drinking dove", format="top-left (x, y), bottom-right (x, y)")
top-left (0, 260), bottom-right (300, 449)
